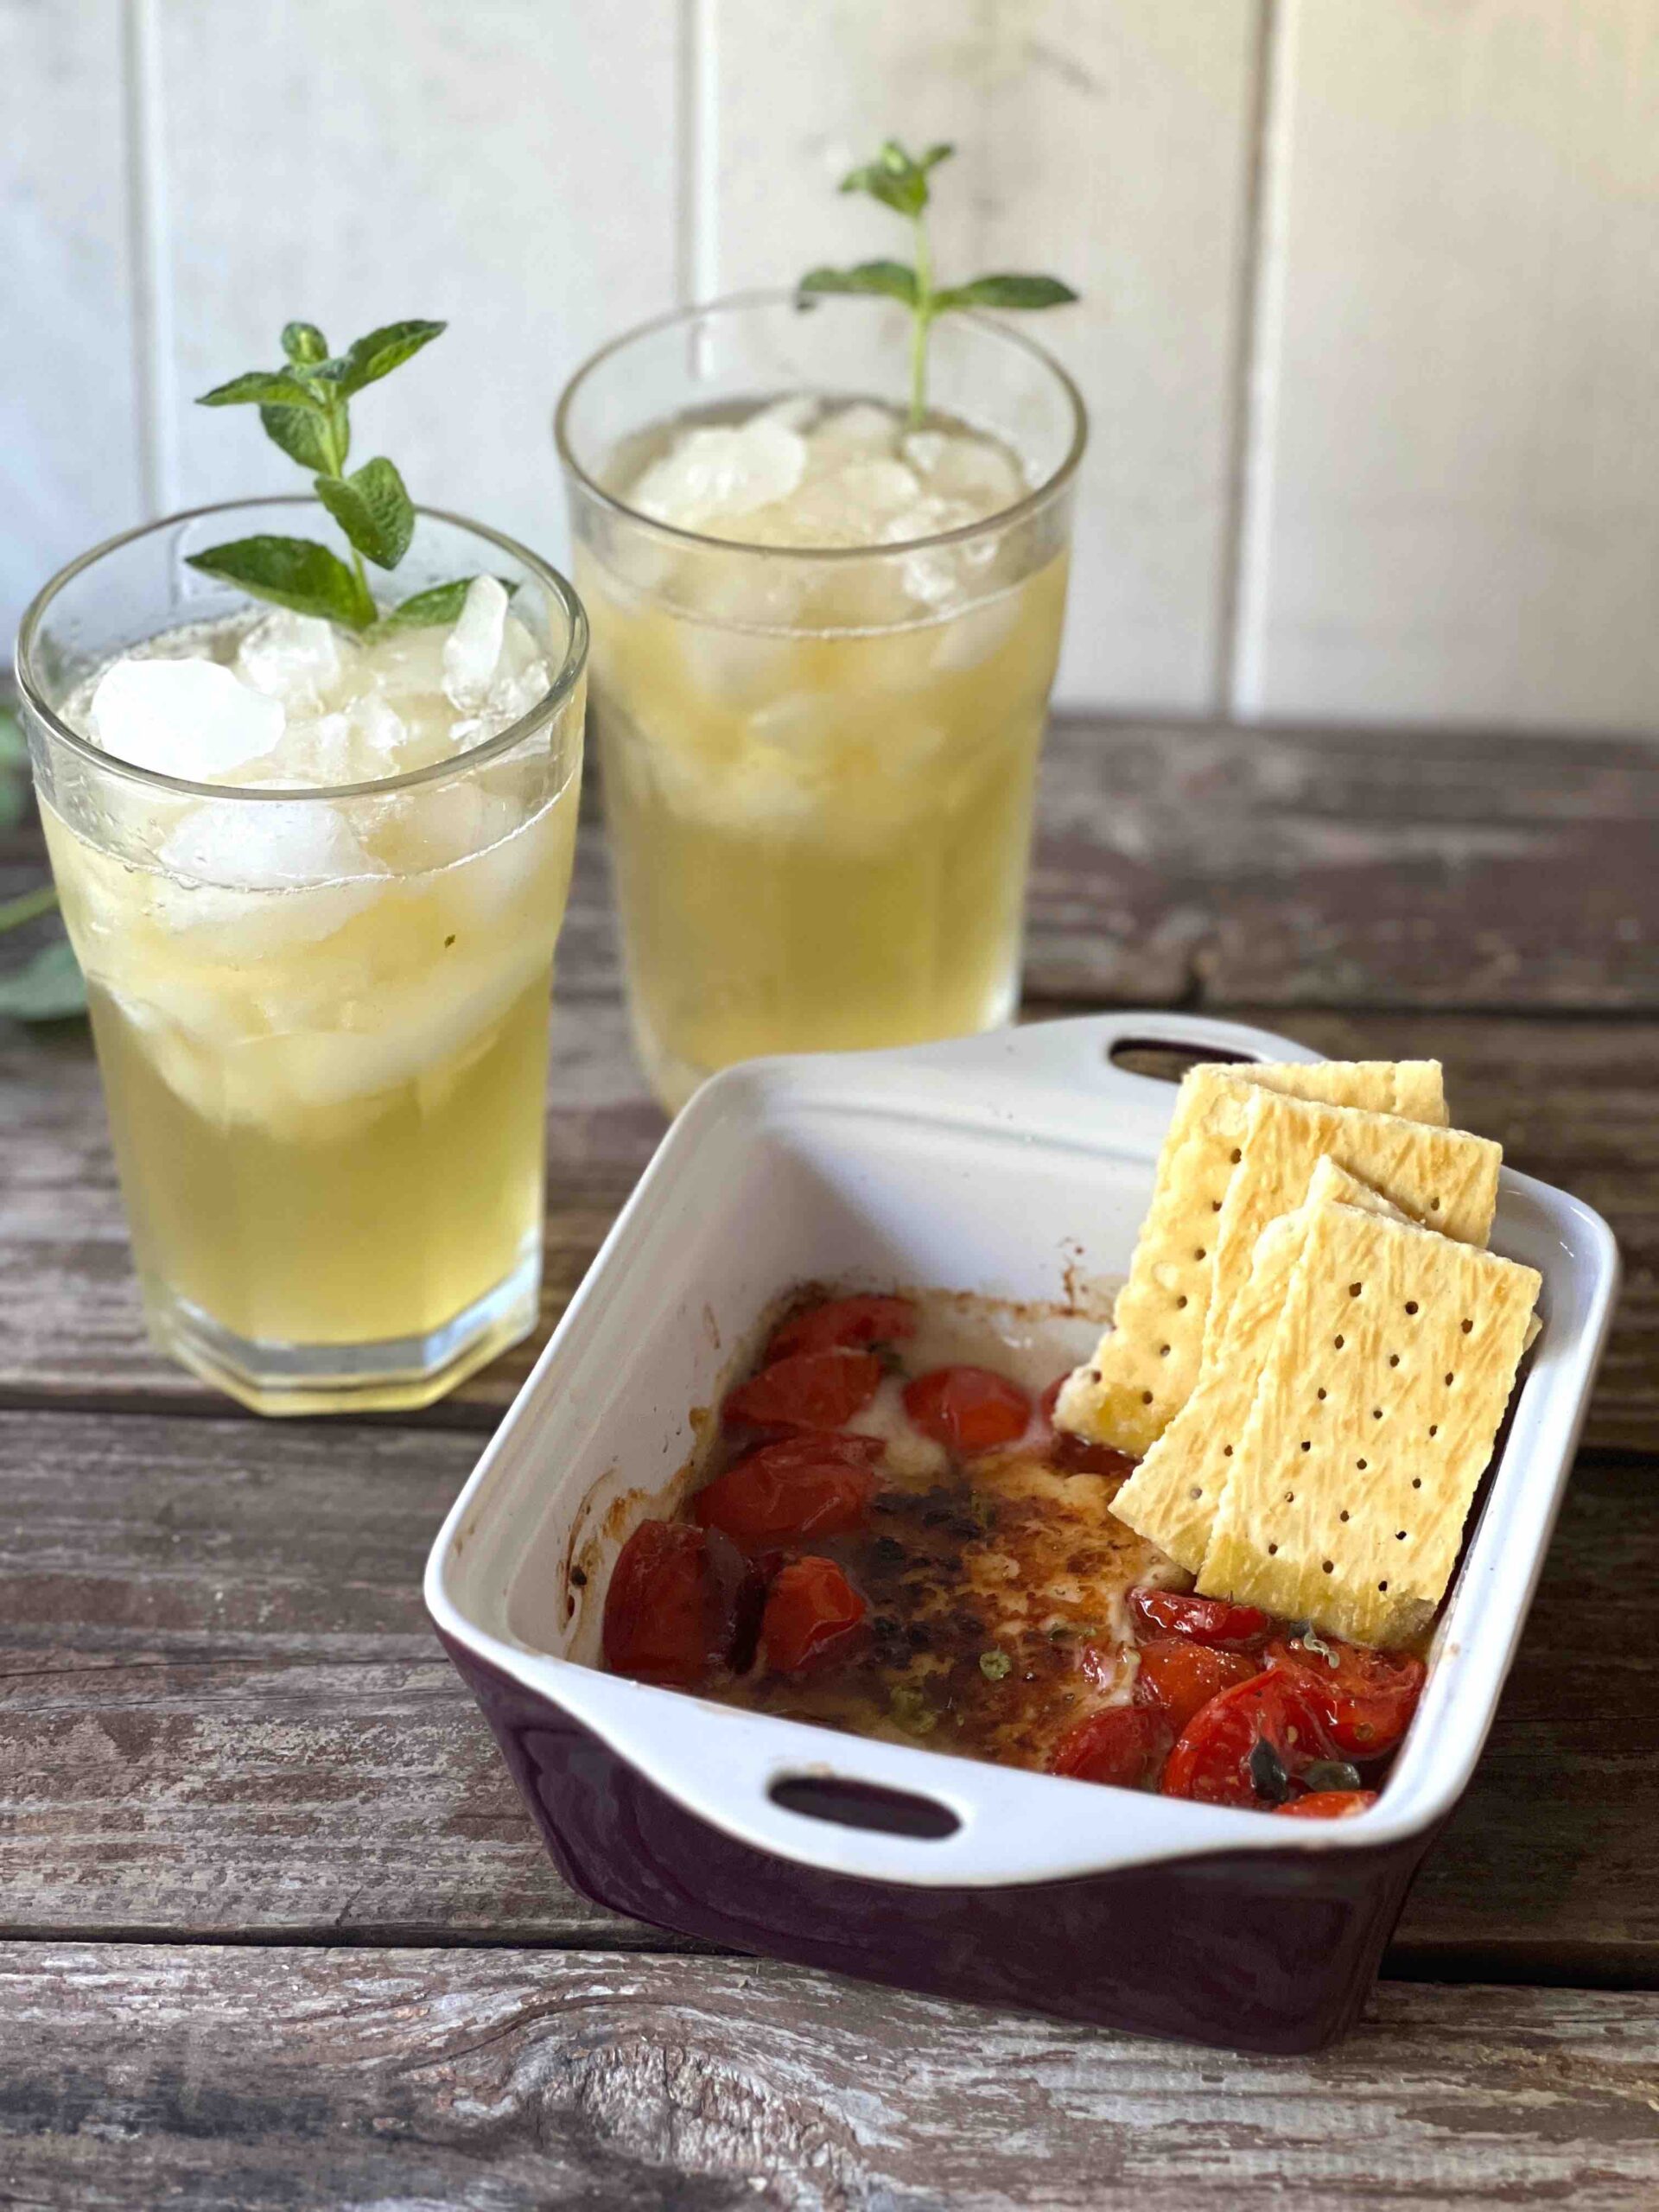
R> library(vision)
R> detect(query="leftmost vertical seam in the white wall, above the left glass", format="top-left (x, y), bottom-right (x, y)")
top-left (122, 0), bottom-right (179, 515)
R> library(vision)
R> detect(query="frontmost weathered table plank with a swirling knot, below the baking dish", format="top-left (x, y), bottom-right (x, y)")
top-left (0, 1944), bottom-right (1659, 2212)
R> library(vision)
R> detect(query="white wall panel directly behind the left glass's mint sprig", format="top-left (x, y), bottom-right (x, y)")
top-left (151, 0), bottom-right (679, 579)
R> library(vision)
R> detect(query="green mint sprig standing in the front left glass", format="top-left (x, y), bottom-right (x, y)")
top-left (188, 321), bottom-right (471, 631)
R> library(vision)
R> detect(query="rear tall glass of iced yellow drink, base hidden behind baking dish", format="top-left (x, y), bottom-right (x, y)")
top-left (557, 294), bottom-right (1086, 1109)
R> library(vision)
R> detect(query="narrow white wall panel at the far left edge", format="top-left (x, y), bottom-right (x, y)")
top-left (0, 0), bottom-right (142, 659)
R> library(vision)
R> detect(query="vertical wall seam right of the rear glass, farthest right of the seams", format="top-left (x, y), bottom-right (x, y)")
top-left (1212, 0), bottom-right (1294, 715)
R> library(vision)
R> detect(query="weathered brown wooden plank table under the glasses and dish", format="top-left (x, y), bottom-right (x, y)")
top-left (0, 726), bottom-right (1659, 2212)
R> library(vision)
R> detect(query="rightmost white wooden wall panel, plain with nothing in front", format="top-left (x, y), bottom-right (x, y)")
top-left (1236, 0), bottom-right (1659, 730)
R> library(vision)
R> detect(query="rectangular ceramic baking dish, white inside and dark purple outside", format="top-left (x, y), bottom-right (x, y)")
top-left (425, 1013), bottom-right (1619, 2050)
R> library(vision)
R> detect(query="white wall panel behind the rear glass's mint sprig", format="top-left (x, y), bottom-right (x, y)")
top-left (696, 0), bottom-right (1259, 710)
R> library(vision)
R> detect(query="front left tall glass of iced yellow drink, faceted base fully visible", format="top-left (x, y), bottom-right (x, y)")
top-left (17, 500), bottom-right (586, 1414)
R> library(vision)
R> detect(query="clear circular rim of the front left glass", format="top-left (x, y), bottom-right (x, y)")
top-left (13, 491), bottom-right (588, 801)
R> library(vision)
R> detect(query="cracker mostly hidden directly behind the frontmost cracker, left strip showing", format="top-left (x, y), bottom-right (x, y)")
top-left (1113, 1159), bottom-right (1405, 1575)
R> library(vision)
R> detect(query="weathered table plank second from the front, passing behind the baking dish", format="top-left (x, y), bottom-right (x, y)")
top-left (0, 1411), bottom-right (1659, 1984)
